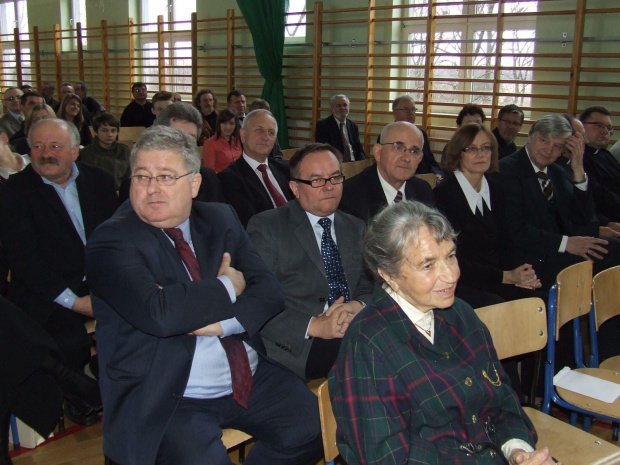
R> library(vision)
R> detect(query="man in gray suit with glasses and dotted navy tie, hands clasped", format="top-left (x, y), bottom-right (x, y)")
top-left (248, 143), bottom-right (373, 380)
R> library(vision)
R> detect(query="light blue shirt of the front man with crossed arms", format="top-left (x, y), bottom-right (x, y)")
top-left (170, 219), bottom-right (258, 399)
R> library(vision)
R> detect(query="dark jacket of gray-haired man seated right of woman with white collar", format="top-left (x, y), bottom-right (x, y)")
top-left (499, 147), bottom-right (598, 286)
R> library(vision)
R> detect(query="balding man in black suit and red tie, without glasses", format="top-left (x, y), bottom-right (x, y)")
top-left (218, 110), bottom-right (293, 226)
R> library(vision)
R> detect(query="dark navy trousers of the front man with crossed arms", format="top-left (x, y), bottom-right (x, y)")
top-left (156, 360), bottom-right (323, 465)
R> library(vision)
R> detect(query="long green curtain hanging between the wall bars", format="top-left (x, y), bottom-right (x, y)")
top-left (237, 0), bottom-right (289, 149)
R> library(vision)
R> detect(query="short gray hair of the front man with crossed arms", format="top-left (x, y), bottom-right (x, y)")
top-left (129, 125), bottom-right (201, 174)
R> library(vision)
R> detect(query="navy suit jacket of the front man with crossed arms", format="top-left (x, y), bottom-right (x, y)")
top-left (86, 202), bottom-right (284, 465)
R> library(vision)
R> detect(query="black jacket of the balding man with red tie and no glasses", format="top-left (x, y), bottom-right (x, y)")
top-left (217, 156), bottom-right (294, 226)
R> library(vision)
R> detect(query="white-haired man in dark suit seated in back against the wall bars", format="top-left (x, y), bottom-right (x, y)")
top-left (314, 94), bottom-right (366, 163)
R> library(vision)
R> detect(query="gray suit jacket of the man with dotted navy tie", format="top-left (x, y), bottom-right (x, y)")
top-left (248, 200), bottom-right (373, 378)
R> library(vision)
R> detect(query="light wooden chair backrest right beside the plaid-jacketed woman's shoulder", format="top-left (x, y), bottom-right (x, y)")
top-left (476, 297), bottom-right (547, 360)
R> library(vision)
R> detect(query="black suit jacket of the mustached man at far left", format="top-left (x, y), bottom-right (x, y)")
top-left (0, 162), bottom-right (118, 323)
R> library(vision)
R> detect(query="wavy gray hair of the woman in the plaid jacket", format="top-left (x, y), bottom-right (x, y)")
top-left (362, 200), bottom-right (456, 282)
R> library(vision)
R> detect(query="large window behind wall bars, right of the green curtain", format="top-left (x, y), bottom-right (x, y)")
top-left (404, 0), bottom-right (537, 114)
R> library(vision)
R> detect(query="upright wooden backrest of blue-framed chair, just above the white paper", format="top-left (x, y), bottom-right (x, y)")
top-left (555, 261), bottom-right (592, 341)
